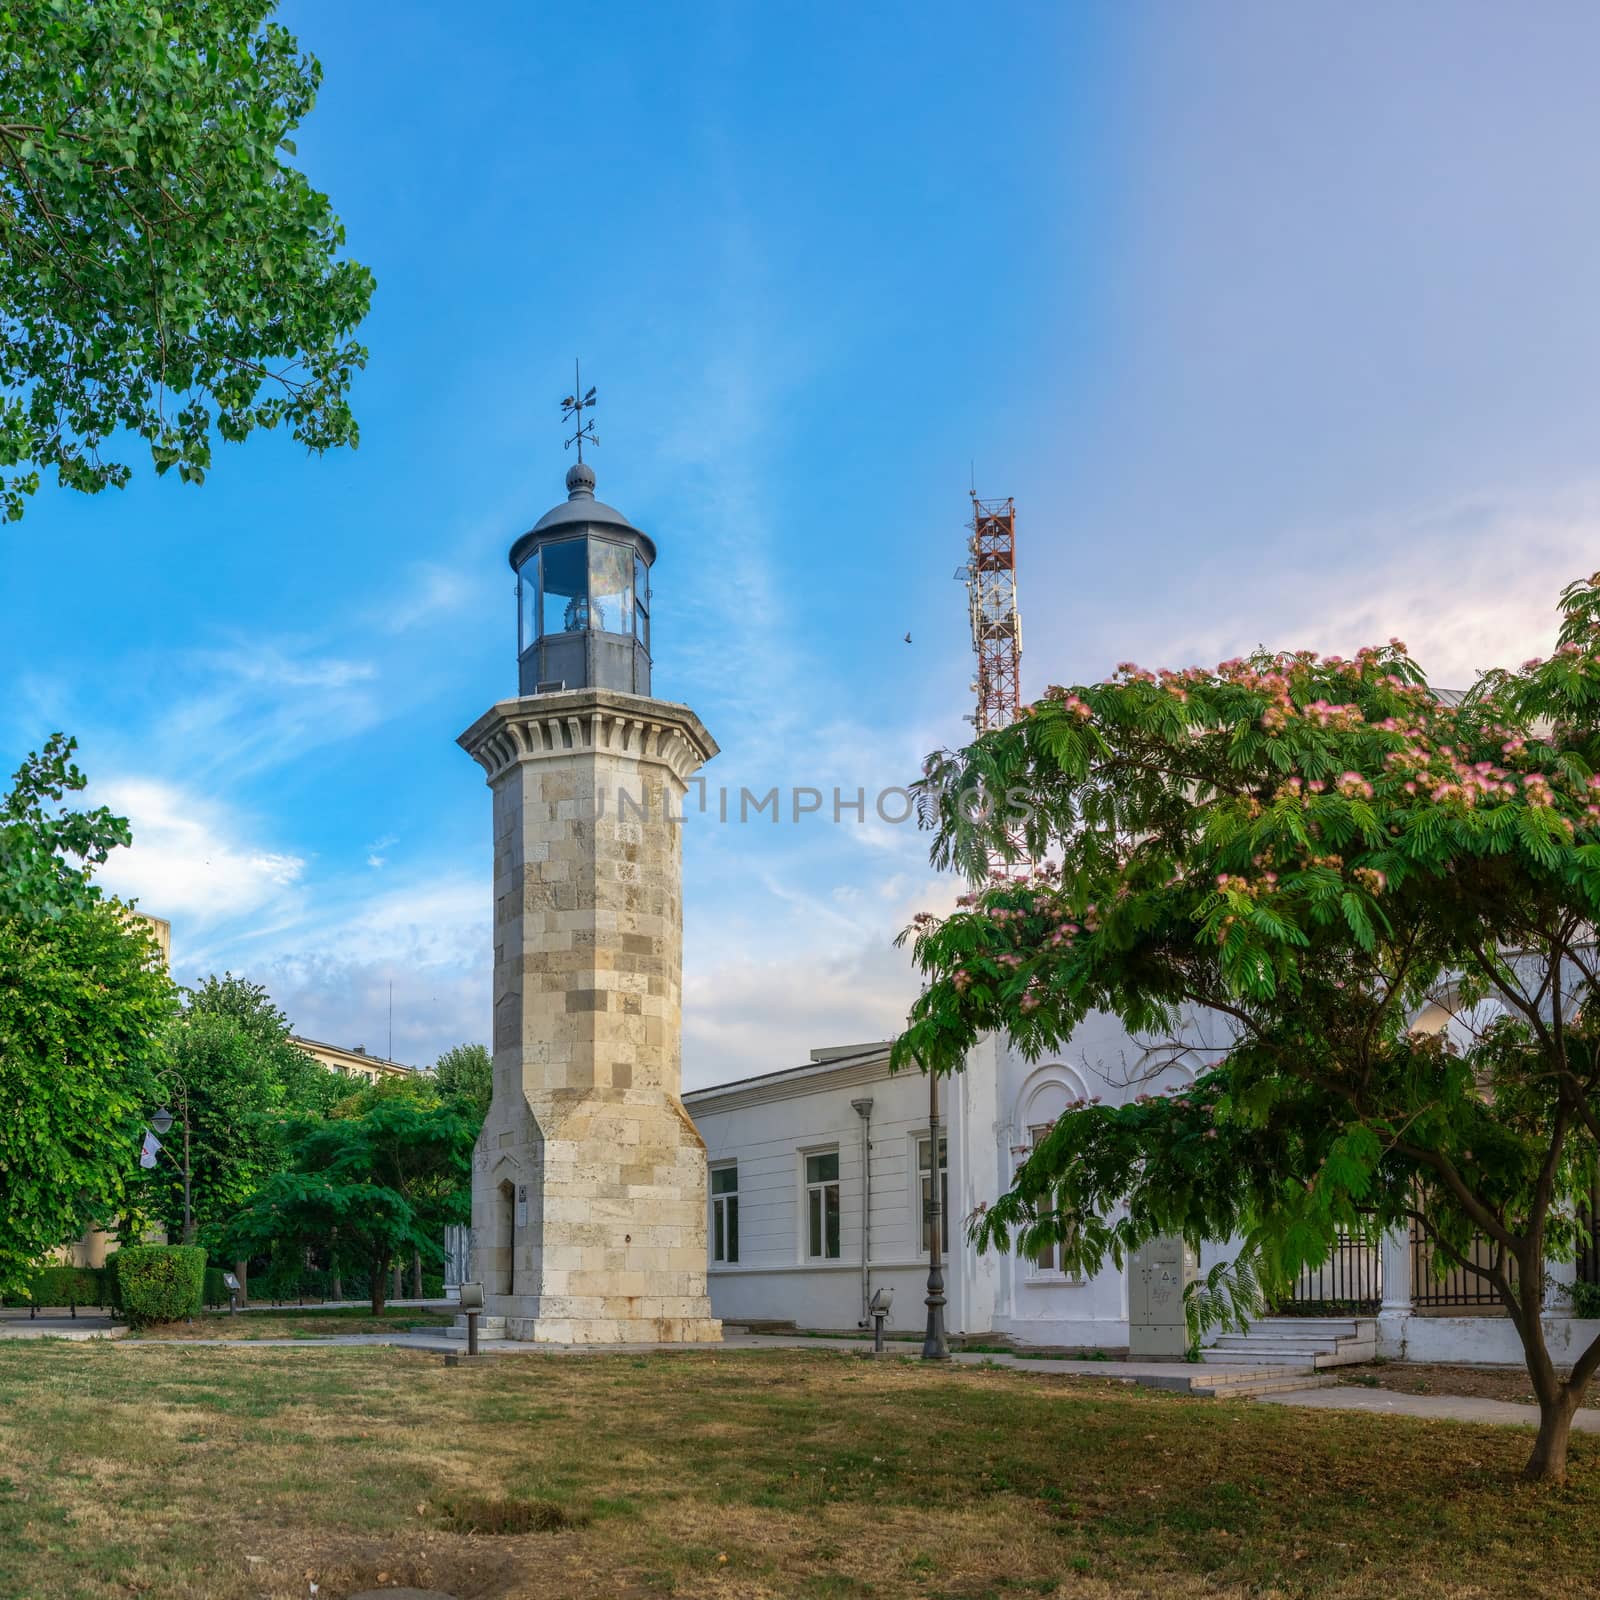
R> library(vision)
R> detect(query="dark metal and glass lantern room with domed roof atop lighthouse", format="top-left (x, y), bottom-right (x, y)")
top-left (510, 461), bottom-right (656, 694)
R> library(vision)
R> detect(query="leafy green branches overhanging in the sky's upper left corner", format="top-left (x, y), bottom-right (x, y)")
top-left (0, 0), bottom-right (373, 520)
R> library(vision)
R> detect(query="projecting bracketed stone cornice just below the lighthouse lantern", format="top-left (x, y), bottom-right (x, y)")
top-left (456, 690), bottom-right (717, 784)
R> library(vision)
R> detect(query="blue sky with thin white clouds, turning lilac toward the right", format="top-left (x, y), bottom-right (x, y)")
top-left (0, 0), bottom-right (1600, 1085)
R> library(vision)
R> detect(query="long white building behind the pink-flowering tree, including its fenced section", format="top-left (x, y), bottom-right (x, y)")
top-left (683, 1008), bottom-right (1600, 1363)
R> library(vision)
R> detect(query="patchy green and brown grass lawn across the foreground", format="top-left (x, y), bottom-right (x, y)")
top-left (0, 1342), bottom-right (1600, 1600)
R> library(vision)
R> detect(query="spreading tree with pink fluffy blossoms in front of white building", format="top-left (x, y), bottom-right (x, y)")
top-left (894, 574), bottom-right (1600, 1478)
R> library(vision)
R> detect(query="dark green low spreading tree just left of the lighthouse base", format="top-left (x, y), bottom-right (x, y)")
top-left (227, 1098), bottom-right (477, 1312)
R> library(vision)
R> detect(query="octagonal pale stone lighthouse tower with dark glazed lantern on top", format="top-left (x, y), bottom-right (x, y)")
top-left (459, 413), bottom-right (722, 1344)
